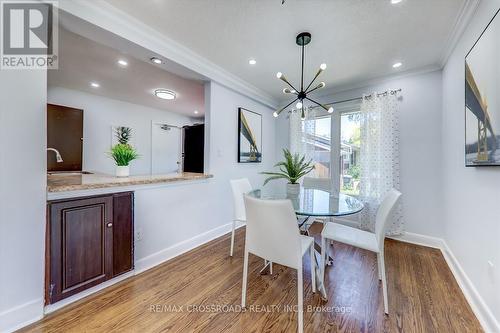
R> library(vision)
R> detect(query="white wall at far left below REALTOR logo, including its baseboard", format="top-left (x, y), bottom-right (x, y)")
top-left (0, 70), bottom-right (47, 332)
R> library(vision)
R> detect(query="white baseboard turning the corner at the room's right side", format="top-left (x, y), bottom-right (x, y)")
top-left (389, 232), bottom-right (500, 333)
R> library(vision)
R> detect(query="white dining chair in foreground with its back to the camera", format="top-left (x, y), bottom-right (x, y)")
top-left (241, 196), bottom-right (316, 332)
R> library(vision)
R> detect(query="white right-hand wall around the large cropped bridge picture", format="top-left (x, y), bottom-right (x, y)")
top-left (441, 0), bottom-right (500, 331)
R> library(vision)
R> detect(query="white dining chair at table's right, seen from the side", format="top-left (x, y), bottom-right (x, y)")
top-left (321, 189), bottom-right (401, 314)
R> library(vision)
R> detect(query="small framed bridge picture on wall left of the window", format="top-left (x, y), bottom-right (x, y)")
top-left (238, 108), bottom-right (262, 163)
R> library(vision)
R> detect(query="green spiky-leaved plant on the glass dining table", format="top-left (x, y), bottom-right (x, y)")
top-left (261, 149), bottom-right (314, 185)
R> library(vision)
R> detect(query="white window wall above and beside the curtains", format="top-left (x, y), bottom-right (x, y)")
top-left (276, 71), bottom-right (444, 237)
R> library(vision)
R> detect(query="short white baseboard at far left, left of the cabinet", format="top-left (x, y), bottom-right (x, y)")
top-left (0, 299), bottom-right (43, 333)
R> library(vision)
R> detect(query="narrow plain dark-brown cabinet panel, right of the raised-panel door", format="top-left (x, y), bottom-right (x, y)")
top-left (113, 192), bottom-right (134, 276)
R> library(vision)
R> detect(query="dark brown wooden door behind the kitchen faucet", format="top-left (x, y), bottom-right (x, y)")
top-left (47, 104), bottom-right (83, 171)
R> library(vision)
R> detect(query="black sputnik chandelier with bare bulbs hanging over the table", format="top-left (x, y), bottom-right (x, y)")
top-left (273, 32), bottom-right (333, 120)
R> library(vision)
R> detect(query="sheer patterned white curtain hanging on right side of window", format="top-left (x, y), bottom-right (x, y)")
top-left (360, 91), bottom-right (404, 235)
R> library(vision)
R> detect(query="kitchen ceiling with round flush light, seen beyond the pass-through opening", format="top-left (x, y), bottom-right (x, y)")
top-left (48, 28), bottom-right (204, 118)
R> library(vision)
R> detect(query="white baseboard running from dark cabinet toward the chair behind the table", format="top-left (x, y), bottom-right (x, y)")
top-left (135, 222), bottom-right (243, 274)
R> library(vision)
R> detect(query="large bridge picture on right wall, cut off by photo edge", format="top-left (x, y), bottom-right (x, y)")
top-left (465, 11), bottom-right (500, 166)
